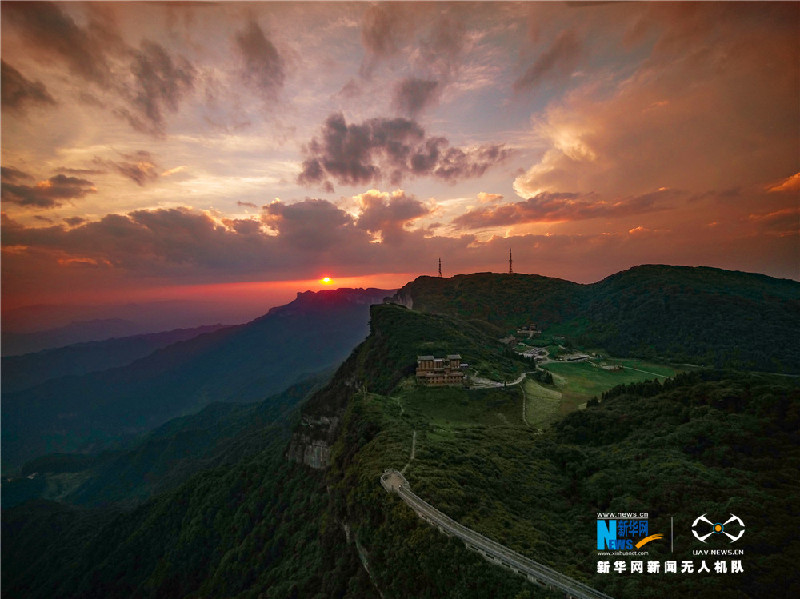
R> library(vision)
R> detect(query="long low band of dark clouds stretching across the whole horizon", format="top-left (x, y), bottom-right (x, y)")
top-left (2, 201), bottom-right (797, 293)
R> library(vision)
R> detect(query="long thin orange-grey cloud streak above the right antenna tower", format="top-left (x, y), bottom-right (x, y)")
top-left (453, 190), bottom-right (680, 229)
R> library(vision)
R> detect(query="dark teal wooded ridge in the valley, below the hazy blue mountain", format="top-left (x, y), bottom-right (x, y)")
top-left (3, 370), bottom-right (333, 509)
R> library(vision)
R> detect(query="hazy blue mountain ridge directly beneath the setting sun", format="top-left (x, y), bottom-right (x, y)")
top-left (2, 289), bottom-right (393, 470)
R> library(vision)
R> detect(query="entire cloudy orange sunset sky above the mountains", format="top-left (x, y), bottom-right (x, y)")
top-left (2, 2), bottom-right (800, 328)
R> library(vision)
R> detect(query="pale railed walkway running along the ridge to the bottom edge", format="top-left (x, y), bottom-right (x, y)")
top-left (381, 470), bottom-right (612, 599)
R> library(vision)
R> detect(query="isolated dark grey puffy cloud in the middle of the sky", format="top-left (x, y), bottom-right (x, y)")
top-left (298, 114), bottom-right (509, 189)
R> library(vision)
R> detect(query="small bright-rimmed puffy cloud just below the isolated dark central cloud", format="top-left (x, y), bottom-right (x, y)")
top-left (356, 190), bottom-right (430, 243)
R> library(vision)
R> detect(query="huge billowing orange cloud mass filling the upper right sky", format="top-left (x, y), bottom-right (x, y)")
top-left (514, 3), bottom-right (800, 198)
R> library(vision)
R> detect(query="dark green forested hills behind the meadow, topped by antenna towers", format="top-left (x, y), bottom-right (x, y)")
top-left (395, 265), bottom-right (800, 374)
